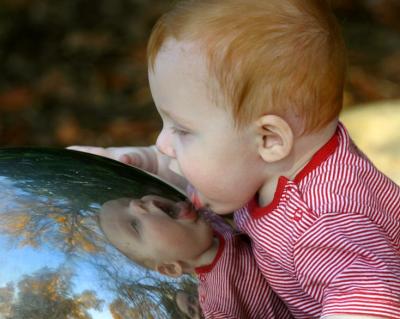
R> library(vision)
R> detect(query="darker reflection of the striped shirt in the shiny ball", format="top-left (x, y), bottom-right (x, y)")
top-left (196, 215), bottom-right (293, 319)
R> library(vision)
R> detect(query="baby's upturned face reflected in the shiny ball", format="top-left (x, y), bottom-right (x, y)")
top-left (100, 195), bottom-right (213, 262)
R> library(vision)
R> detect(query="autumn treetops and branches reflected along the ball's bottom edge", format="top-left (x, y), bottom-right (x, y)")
top-left (0, 266), bottom-right (196, 319)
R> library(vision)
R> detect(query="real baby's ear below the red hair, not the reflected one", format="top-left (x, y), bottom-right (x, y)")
top-left (256, 115), bottom-right (294, 163)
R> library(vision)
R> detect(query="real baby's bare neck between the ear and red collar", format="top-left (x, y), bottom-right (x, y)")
top-left (258, 120), bottom-right (338, 207)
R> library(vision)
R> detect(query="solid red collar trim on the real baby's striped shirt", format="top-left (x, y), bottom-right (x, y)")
top-left (248, 129), bottom-right (339, 219)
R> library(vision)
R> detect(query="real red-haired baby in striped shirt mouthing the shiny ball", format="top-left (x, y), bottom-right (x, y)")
top-left (70, 0), bottom-right (400, 319)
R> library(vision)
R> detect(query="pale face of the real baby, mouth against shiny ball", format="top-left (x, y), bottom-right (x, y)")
top-left (149, 39), bottom-right (265, 214)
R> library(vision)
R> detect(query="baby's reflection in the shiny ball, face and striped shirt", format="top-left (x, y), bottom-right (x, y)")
top-left (100, 195), bottom-right (291, 319)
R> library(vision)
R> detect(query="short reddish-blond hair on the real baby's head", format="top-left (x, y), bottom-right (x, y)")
top-left (148, 0), bottom-right (346, 132)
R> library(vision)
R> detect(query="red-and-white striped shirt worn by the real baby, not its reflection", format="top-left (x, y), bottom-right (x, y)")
top-left (235, 124), bottom-right (400, 319)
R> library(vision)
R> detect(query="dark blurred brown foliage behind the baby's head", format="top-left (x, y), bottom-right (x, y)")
top-left (0, 0), bottom-right (400, 147)
